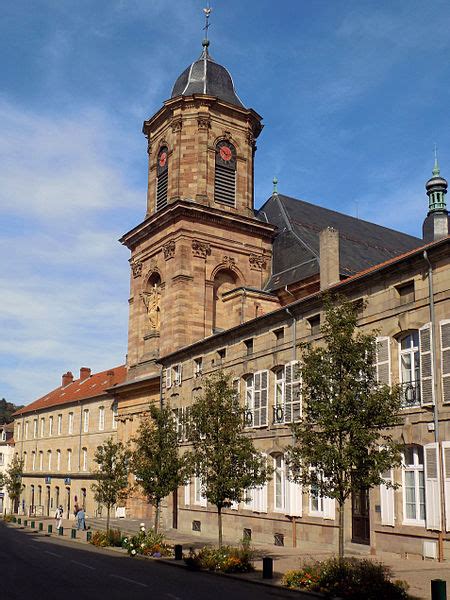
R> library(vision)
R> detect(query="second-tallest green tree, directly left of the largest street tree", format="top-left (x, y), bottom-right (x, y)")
top-left (190, 371), bottom-right (270, 546)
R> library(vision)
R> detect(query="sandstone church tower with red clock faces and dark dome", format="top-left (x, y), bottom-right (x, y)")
top-left (121, 17), bottom-right (278, 379)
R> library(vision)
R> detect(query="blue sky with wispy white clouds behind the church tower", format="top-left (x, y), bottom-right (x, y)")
top-left (0, 0), bottom-right (450, 403)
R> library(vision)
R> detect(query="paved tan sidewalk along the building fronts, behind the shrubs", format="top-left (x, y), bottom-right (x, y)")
top-left (12, 518), bottom-right (450, 600)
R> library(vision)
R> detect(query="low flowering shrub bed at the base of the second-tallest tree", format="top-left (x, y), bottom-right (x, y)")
top-left (184, 544), bottom-right (254, 573)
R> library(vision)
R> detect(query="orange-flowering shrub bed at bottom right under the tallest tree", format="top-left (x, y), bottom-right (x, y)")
top-left (282, 558), bottom-right (410, 600)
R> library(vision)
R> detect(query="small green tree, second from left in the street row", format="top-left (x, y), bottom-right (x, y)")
top-left (92, 438), bottom-right (131, 533)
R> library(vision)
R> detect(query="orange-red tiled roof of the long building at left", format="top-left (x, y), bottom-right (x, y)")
top-left (13, 365), bottom-right (127, 417)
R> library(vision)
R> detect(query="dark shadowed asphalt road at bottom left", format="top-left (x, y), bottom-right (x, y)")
top-left (0, 522), bottom-right (311, 600)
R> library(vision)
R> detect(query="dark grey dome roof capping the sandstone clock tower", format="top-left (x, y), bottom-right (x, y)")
top-left (171, 40), bottom-right (244, 108)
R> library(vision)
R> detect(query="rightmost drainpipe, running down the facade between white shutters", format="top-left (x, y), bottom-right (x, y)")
top-left (423, 250), bottom-right (445, 562)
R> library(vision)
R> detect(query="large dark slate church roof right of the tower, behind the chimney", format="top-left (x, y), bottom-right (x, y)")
top-left (257, 194), bottom-right (423, 291)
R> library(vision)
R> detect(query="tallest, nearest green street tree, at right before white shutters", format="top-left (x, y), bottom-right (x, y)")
top-left (287, 298), bottom-right (401, 557)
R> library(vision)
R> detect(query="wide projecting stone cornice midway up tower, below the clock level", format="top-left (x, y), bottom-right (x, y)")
top-left (119, 200), bottom-right (276, 249)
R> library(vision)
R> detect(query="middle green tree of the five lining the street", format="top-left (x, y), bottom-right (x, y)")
top-left (131, 404), bottom-right (188, 531)
